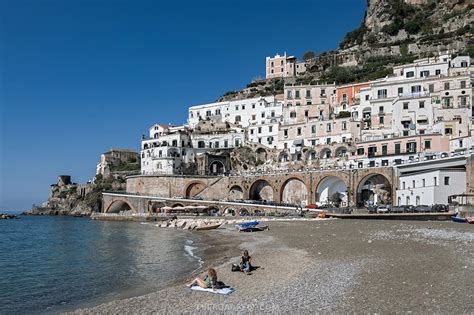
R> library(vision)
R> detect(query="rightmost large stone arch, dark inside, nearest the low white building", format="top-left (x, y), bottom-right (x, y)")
top-left (356, 173), bottom-right (392, 206)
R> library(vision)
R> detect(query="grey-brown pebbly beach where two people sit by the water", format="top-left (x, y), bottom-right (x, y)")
top-left (71, 219), bottom-right (474, 314)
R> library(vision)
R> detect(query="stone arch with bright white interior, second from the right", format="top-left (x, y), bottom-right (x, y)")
top-left (316, 175), bottom-right (349, 206)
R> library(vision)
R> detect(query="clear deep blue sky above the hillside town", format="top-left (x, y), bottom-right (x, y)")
top-left (0, 0), bottom-right (366, 211)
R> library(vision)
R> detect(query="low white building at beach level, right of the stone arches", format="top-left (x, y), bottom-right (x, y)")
top-left (396, 169), bottom-right (466, 206)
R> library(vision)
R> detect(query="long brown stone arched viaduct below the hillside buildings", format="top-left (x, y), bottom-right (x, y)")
top-left (102, 167), bottom-right (398, 213)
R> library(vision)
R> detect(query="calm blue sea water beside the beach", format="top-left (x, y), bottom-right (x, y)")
top-left (0, 216), bottom-right (200, 314)
